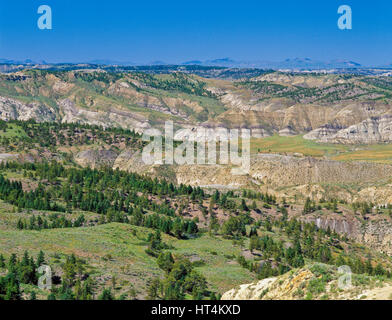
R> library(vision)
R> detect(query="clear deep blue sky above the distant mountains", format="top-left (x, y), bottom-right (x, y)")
top-left (0, 0), bottom-right (392, 65)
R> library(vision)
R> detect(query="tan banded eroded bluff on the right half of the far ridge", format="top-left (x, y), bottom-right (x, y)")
top-left (214, 80), bottom-right (392, 138)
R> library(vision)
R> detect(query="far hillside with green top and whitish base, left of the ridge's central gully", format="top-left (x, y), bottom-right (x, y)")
top-left (0, 70), bottom-right (224, 132)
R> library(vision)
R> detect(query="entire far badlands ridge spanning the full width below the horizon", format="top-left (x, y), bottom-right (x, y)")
top-left (0, 67), bottom-right (392, 142)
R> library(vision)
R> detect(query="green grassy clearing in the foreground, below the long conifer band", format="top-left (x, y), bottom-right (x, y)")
top-left (0, 223), bottom-right (255, 297)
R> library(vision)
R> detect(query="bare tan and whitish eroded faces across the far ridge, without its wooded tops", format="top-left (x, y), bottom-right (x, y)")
top-left (0, 70), bottom-right (392, 143)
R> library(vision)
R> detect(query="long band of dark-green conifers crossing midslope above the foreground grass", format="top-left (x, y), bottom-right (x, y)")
top-left (0, 162), bottom-right (284, 242)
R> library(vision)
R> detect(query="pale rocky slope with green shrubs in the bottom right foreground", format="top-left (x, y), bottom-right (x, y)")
top-left (222, 264), bottom-right (392, 300)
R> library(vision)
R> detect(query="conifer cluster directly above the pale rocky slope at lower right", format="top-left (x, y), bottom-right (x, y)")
top-left (237, 218), bottom-right (391, 279)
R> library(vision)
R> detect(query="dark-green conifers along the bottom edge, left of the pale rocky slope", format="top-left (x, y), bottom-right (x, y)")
top-left (0, 248), bottom-right (219, 300)
